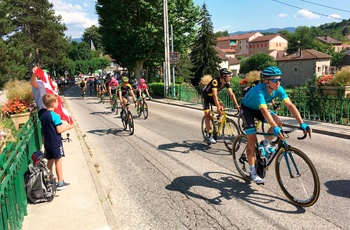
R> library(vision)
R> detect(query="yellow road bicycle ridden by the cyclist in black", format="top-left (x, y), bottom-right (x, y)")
top-left (201, 105), bottom-right (240, 152)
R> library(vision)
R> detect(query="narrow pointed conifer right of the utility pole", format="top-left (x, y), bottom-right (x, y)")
top-left (190, 3), bottom-right (220, 85)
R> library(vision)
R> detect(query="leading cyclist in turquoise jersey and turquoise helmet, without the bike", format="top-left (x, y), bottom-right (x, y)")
top-left (240, 66), bottom-right (312, 184)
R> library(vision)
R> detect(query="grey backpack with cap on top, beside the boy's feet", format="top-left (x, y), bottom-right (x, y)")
top-left (24, 151), bottom-right (57, 204)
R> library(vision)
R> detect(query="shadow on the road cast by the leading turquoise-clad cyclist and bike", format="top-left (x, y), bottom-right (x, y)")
top-left (165, 172), bottom-right (305, 214)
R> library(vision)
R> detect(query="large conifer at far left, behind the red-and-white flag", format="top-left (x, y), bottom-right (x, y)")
top-left (0, 0), bottom-right (68, 82)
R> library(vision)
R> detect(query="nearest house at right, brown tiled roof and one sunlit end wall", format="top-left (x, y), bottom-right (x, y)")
top-left (276, 49), bottom-right (331, 87)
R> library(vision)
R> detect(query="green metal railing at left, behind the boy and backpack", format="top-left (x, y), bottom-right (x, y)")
top-left (0, 113), bottom-right (42, 230)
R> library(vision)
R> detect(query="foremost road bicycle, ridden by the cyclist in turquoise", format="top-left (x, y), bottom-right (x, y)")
top-left (232, 129), bottom-right (320, 207)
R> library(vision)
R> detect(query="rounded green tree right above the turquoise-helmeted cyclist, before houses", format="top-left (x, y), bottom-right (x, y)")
top-left (240, 53), bottom-right (277, 73)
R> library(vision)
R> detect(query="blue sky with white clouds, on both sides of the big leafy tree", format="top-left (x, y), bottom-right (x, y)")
top-left (49, 0), bottom-right (350, 38)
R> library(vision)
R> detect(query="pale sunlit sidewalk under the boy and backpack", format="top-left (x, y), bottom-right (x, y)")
top-left (22, 97), bottom-right (117, 230)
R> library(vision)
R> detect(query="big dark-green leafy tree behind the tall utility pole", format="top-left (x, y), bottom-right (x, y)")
top-left (96, 0), bottom-right (198, 78)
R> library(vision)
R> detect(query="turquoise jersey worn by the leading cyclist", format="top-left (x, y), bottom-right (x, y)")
top-left (242, 83), bottom-right (290, 110)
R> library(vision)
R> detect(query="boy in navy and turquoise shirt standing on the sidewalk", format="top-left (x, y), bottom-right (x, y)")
top-left (40, 94), bottom-right (74, 191)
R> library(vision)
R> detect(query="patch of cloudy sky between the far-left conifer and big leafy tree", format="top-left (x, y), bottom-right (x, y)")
top-left (49, 0), bottom-right (98, 38)
